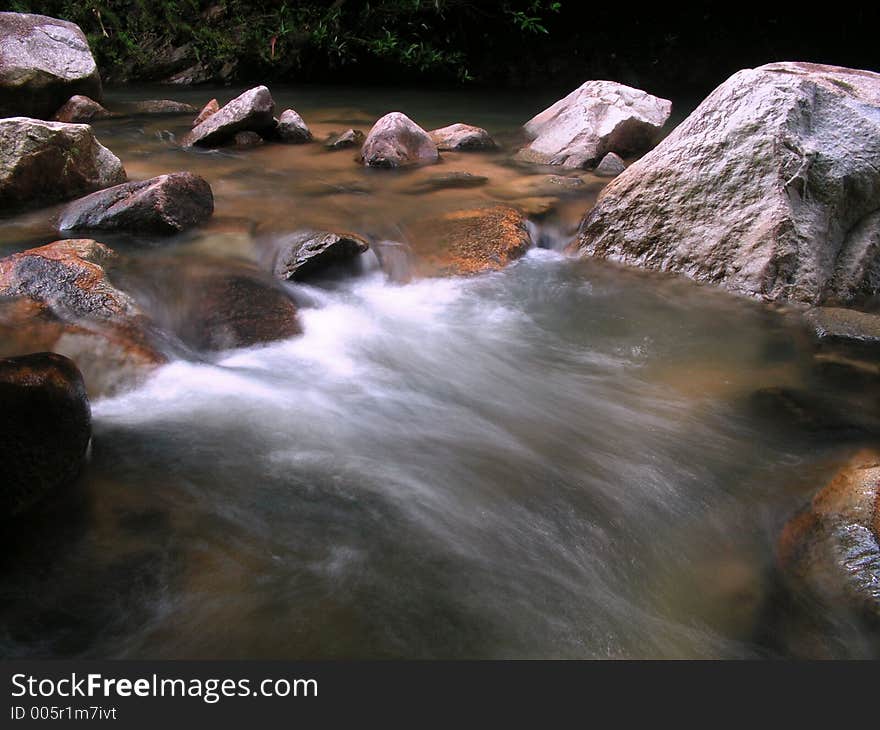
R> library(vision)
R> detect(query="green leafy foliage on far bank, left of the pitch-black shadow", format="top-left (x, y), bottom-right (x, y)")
top-left (3, 0), bottom-right (561, 82)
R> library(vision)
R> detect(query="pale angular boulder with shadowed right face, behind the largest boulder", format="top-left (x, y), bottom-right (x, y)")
top-left (517, 81), bottom-right (672, 167)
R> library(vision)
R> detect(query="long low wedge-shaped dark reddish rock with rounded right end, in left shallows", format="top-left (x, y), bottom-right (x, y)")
top-left (58, 172), bottom-right (214, 235)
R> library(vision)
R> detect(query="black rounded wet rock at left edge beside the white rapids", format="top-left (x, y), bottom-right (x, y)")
top-left (0, 352), bottom-right (91, 520)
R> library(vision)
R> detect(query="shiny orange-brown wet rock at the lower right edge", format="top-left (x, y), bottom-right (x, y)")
top-left (777, 450), bottom-right (880, 621)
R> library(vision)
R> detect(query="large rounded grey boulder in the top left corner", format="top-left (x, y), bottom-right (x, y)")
top-left (0, 13), bottom-right (101, 118)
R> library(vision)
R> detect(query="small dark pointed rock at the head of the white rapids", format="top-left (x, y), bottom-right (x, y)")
top-left (272, 231), bottom-right (370, 281)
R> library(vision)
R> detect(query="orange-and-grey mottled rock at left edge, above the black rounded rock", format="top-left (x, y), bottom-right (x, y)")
top-left (0, 239), bottom-right (140, 323)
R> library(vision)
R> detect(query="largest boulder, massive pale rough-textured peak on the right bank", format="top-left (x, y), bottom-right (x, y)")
top-left (577, 63), bottom-right (880, 304)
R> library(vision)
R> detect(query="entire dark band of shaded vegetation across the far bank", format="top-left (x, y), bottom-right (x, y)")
top-left (0, 0), bottom-right (880, 95)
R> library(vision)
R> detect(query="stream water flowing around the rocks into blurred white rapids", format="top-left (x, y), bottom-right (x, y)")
top-left (0, 84), bottom-right (880, 658)
